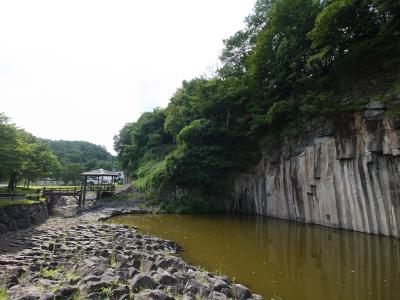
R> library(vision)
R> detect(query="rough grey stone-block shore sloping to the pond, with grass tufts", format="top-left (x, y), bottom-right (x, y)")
top-left (0, 208), bottom-right (262, 300)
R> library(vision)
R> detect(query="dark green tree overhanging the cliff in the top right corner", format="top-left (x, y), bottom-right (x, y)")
top-left (308, 0), bottom-right (400, 68)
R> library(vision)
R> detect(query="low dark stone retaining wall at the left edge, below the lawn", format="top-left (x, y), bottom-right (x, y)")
top-left (0, 202), bottom-right (48, 234)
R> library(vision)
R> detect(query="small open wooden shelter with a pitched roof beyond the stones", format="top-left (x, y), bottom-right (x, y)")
top-left (79, 169), bottom-right (119, 206)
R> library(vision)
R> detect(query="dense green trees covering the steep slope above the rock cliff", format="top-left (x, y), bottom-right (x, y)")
top-left (115, 0), bottom-right (400, 211)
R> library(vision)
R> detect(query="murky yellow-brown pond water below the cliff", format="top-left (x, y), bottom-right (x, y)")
top-left (110, 215), bottom-right (400, 300)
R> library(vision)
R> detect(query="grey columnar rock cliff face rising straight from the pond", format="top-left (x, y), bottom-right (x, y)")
top-left (224, 103), bottom-right (400, 237)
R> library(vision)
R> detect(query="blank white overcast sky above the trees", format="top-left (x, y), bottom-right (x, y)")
top-left (0, 0), bottom-right (255, 154)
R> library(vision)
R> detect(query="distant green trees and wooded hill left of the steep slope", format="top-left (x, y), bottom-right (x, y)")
top-left (0, 113), bottom-right (114, 190)
